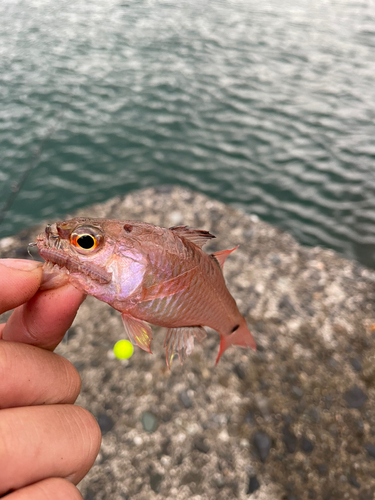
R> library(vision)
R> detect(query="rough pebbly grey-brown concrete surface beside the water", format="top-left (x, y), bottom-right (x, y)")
top-left (0, 187), bottom-right (375, 500)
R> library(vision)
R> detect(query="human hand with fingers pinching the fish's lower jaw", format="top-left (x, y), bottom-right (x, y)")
top-left (0, 259), bottom-right (101, 500)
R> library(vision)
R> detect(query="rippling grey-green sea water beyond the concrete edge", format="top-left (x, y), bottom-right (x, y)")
top-left (0, 0), bottom-right (375, 267)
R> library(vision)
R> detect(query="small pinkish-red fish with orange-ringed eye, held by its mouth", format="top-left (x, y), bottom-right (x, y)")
top-left (35, 217), bottom-right (256, 368)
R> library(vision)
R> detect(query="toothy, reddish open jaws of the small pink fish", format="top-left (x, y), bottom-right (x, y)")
top-left (35, 224), bottom-right (112, 285)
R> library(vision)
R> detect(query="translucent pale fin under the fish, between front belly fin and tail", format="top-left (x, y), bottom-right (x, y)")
top-left (164, 326), bottom-right (207, 368)
